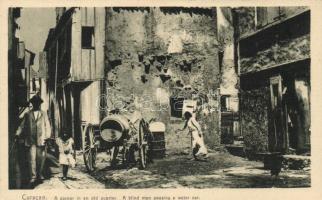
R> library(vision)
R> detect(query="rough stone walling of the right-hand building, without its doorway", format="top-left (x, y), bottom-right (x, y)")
top-left (236, 7), bottom-right (310, 153)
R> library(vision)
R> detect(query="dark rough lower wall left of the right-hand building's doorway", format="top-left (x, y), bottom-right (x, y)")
top-left (240, 86), bottom-right (270, 154)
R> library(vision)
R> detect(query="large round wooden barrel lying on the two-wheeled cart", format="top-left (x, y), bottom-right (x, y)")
top-left (100, 115), bottom-right (130, 144)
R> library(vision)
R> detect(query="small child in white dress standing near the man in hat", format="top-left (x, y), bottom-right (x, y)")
top-left (56, 131), bottom-right (76, 181)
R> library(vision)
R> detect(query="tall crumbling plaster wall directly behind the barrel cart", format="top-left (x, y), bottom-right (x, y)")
top-left (106, 8), bottom-right (220, 152)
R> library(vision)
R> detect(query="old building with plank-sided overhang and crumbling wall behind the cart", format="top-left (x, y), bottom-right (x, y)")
top-left (44, 8), bottom-right (220, 152)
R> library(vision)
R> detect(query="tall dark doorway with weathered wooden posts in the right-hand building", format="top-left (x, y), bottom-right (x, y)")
top-left (269, 70), bottom-right (310, 154)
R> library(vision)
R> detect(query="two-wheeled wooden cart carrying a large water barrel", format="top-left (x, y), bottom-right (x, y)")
top-left (82, 115), bottom-right (153, 172)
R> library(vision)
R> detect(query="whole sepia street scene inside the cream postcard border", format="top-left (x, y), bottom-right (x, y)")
top-left (7, 6), bottom-right (311, 190)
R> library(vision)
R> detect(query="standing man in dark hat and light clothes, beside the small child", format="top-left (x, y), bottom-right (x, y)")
top-left (16, 94), bottom-right (51, 186)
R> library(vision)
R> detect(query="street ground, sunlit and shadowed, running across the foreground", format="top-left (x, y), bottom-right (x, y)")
top-left (36, 148), bottom-right (310, 189)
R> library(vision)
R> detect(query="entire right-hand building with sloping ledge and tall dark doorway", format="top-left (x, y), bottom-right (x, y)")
top-left (235, 7), bottom-right (310, 154)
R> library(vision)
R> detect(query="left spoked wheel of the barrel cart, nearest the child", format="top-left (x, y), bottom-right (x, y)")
top-left (83, 125), bottom-right (97, 172)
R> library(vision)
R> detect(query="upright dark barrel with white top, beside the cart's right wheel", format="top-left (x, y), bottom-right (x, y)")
top-left (149, 122), bottom-right (166, 159)
